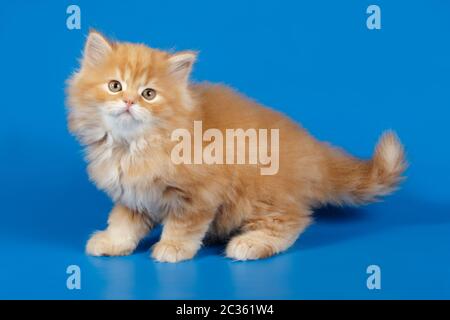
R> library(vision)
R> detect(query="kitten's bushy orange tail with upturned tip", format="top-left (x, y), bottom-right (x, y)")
top-left (320, 131), bottom-right (407, 205)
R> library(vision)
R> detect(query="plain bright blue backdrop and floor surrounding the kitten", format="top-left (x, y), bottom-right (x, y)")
top-left (0, 0), bottom-right (450, 299)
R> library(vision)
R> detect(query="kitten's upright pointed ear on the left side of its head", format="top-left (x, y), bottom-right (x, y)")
top-left (83, 30), bottom-right (112, 67)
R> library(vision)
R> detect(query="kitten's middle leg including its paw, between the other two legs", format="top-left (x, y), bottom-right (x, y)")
top-left (152, 211), bottom-right (213, 262)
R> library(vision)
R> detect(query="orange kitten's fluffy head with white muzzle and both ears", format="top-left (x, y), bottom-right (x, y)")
top-left (68, 31), bottom-right (196, 143)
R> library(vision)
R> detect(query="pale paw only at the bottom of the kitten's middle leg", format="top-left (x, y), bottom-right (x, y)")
top-left (152, 240), bottom-right (197, 262)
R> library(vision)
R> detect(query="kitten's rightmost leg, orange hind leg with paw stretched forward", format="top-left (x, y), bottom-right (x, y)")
top-left (226, 208), bottom-right (311, 260)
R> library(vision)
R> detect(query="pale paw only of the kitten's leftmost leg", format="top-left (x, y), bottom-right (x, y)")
top-left (86, 231), bottom-right (136, 256)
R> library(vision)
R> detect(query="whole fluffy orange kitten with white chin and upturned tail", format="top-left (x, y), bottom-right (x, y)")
top-left (67, 31), bottom-right (406, 262)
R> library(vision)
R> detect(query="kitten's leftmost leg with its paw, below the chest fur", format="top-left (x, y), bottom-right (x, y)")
top-left (86, 205), bottom-right (152, 256)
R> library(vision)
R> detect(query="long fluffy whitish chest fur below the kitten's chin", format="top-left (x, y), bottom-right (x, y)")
top-left (87, 138), bottom-right (170, 220)
